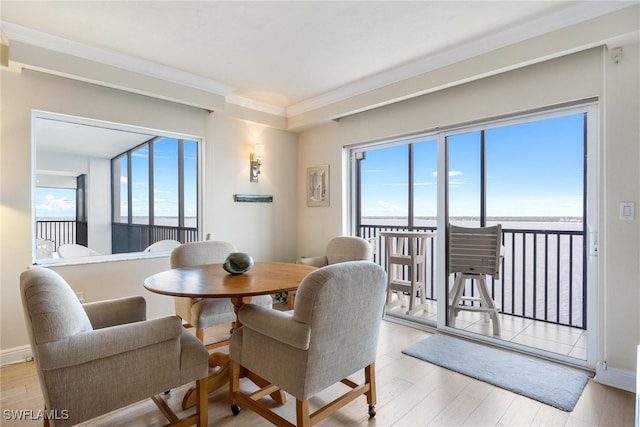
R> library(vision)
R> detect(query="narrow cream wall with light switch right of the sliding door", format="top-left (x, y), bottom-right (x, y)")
top-left (597, 38), bottom-right (640, 386)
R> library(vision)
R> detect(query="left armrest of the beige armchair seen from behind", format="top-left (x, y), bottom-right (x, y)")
top-left (238, 304), bottom-right (311, 350)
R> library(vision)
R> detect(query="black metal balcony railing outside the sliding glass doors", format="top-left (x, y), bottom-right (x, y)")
top-left (360, 225), bottom-right (587, 329)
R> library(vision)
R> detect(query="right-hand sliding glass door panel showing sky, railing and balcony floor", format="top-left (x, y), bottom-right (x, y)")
top-left (445, 112), bottom-right (587, 357)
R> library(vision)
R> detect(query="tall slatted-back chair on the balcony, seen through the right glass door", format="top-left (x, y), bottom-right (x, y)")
top-left (448, 224), bottom-right (502, 337)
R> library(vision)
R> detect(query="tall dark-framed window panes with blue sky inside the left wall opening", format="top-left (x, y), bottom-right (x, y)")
top-left (112, 137), bottom-right (198, 253)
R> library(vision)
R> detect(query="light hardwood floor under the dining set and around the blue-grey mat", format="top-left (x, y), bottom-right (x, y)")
top-left (0, 321), bottom-right (635, 427)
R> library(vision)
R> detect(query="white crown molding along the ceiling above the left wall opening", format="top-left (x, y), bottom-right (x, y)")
top-left (1, 21), bottom-right (233, 96)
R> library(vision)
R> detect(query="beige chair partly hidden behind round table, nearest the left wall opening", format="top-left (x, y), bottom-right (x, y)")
top-left (171, 240), bottom-right (273, 348)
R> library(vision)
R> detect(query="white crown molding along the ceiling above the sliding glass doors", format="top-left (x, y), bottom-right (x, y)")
top-left (286, 1), bottom-right (638, 117)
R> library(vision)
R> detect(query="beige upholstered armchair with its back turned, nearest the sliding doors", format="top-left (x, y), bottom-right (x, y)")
top-left (229, 261), bottom-right (387, 426)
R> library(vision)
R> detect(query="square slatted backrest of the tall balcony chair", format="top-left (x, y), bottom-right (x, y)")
top-left (449, 224), bottom-right (502, 280)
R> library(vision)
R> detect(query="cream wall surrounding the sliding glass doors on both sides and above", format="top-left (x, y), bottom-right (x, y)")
top-left (297, 44), bottom-right (640, 381)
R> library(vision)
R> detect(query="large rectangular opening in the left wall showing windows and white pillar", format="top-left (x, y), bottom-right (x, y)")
top-left (33, 112), bottom-right (201, 264)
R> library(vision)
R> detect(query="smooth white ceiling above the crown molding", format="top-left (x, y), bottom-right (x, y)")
top-left (0, 0), bottom-right (633, 115)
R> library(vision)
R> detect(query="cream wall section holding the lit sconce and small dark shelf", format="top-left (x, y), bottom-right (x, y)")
top-left (204, 112), bottom-right (297, 261)
